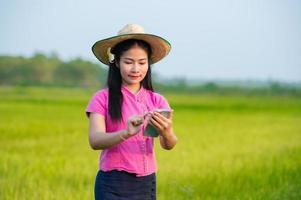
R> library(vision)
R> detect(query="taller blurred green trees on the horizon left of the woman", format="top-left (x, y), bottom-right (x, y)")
top-left (0, 53), bottom-right (107, 87)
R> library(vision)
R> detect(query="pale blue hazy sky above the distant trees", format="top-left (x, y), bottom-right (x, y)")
top-left (0, 0), bottom-right (301, 82)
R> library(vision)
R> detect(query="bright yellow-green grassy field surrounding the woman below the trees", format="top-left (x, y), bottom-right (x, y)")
top-left (0, 87), bottom-right (301, 200)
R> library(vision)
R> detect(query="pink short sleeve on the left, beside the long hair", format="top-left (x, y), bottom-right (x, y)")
top-left (86, 89), bottom-right (108, 117)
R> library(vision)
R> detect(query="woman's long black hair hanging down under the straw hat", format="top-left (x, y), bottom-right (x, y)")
top-left (107, 39), bottom-right (153, 121)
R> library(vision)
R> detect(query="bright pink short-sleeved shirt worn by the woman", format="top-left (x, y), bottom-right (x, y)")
top-left (86, 86), bottom-right (170, 176)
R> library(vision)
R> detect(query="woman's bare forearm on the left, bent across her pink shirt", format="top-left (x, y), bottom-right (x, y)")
top-left (89, 130), bottom-right (128, 150)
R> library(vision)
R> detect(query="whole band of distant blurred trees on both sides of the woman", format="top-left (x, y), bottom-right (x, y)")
top-left (0, 53), bottom-right (301, 96)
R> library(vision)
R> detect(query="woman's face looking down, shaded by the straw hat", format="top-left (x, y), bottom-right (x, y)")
top-left (119, 45), bottom-right (148, 86)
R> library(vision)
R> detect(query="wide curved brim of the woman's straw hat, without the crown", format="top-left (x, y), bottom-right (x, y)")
top-left (92, 33), bottom-right (171, 65)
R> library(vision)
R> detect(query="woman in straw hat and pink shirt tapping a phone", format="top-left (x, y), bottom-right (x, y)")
top-left (86, 24), bottom-right (177, 200)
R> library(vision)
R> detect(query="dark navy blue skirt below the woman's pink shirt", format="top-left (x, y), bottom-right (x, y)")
top-left (94, 170), bottom-right (156, 200)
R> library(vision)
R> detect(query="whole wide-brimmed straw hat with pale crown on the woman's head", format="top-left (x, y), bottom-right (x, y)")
top-left (92, 24), bottom-right (171, 65)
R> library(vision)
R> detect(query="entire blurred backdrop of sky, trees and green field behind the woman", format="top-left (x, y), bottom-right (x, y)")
top-left (0, 0), bottom-right (301, 199)
